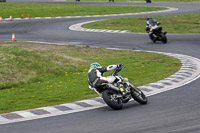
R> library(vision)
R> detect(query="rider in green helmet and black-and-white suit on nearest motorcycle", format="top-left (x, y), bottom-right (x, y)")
top-left (88, 62), bottom-right (125, 94)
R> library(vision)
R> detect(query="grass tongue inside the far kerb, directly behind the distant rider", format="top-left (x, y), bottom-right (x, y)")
top-left (83, 13), bottom-right (200, 33)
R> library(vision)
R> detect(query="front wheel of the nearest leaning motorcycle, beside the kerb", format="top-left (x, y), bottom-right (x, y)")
top-left (131, 87), bottom-right (148, 104)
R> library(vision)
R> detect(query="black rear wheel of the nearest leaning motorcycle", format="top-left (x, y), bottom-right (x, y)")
top-left (102, 89), bottom-right (123, 110)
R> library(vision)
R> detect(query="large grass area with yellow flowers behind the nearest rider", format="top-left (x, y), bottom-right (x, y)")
top-left (0, 42), bottom-right (181, 113)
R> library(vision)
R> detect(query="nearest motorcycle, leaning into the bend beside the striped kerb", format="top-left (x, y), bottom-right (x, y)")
top-left (95, 65), bottom-right (148, 110)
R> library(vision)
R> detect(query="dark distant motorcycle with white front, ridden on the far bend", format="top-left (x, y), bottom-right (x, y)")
top-left (149, 23), bottom-right (167, 43)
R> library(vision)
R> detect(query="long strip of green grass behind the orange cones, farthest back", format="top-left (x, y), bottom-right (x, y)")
top-left (0, 2), bottom-right (166, 18)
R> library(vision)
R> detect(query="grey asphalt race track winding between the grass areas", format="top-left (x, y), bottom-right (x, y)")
top-left (0, 0), bottom-right (200, 133)
